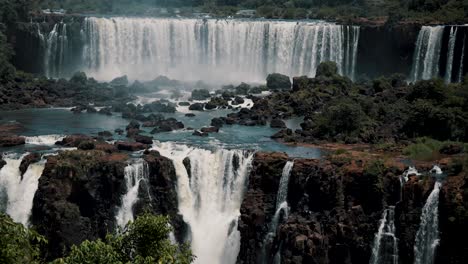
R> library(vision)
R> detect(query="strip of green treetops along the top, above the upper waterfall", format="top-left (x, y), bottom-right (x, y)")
top-left (35, 0), bottom-right (468, 23)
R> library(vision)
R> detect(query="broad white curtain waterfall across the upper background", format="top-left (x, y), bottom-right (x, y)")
top-left (83, 17), bottom-right (359, 82)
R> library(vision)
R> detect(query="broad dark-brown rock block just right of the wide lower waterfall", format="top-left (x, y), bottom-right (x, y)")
top-left (238, 153), bottom-right (408, 263)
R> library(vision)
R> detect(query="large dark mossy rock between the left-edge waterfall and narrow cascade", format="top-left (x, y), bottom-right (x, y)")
top-left (31, 150), bottom-right (128, 259)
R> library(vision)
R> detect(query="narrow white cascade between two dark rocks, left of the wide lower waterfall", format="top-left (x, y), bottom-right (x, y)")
top-left (115, 159), bottom-right (149, 228)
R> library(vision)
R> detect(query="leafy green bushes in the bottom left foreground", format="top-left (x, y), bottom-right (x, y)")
top-left (0, 213), bottom-right (194, 264)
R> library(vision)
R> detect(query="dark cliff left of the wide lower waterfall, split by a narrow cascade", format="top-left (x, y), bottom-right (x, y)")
top-left (32, 150), bottom-right (184, 259)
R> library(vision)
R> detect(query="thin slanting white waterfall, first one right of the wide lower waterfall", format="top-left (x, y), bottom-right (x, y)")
top-left (259, 161), bottom-right (294, 263)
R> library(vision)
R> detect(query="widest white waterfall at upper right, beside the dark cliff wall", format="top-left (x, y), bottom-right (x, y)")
top-left (411, 26), bottom-right (444, 82)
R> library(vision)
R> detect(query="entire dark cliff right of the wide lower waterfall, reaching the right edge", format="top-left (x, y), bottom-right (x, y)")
top-left (238, 153), bottom-right (468, 263)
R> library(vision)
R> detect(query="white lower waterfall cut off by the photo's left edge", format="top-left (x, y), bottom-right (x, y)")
top-left (0, 154), bottom-right (45, 226)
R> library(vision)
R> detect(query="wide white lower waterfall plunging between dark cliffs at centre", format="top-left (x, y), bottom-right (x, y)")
top-left (154, 143), bottom-right (253, 264)
